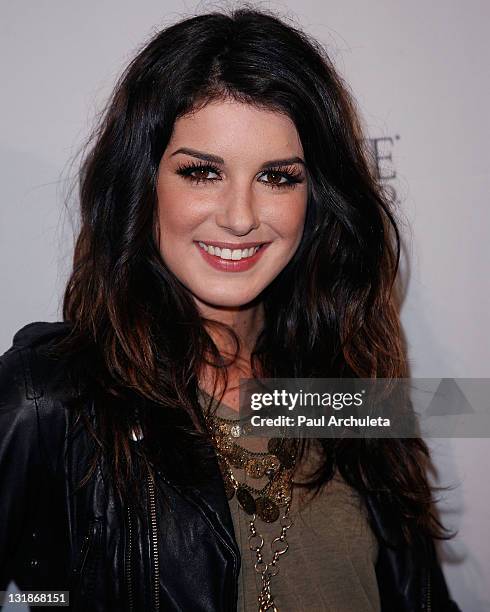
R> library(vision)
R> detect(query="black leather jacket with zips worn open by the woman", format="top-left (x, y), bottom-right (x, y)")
top-left (0, 323), bottom-right (459, 612)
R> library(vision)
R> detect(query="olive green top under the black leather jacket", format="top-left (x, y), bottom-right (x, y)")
top-left (198, 392), bottom-right (380, 612)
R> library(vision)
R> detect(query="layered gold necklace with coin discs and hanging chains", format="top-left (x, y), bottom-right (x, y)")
top-left (205, 396), bottom-right (298, 612)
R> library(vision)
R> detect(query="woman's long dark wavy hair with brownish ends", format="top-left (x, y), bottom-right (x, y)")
top-left (54, 7), bottom-right (447, 541)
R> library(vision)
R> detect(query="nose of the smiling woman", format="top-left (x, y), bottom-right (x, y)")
top-left (216, 184), bottom-right (260, 236)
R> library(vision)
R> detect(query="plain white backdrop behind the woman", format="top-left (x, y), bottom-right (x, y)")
top-left (0, 0), bottom-right (490, 612)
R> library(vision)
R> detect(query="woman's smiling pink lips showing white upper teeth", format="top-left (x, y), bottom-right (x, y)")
top-left (195, 241), bottom-right (270, 272)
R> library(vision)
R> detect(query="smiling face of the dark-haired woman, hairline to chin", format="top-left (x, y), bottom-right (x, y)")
top-left (157, 101), bottom-right (307, 314)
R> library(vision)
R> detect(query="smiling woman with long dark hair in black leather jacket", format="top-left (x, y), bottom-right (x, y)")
top-left (0, 9), bottom-right (458, 612)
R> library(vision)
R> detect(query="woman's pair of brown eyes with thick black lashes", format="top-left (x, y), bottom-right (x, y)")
top-left (176, 161), bottom-right (304, 189)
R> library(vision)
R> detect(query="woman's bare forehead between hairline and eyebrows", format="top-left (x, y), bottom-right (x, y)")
top-left (169, 100), bottom-right (303, 159)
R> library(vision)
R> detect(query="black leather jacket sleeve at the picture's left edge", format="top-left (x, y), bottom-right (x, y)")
top-left (0, 348), bottom-right (41, 590)
